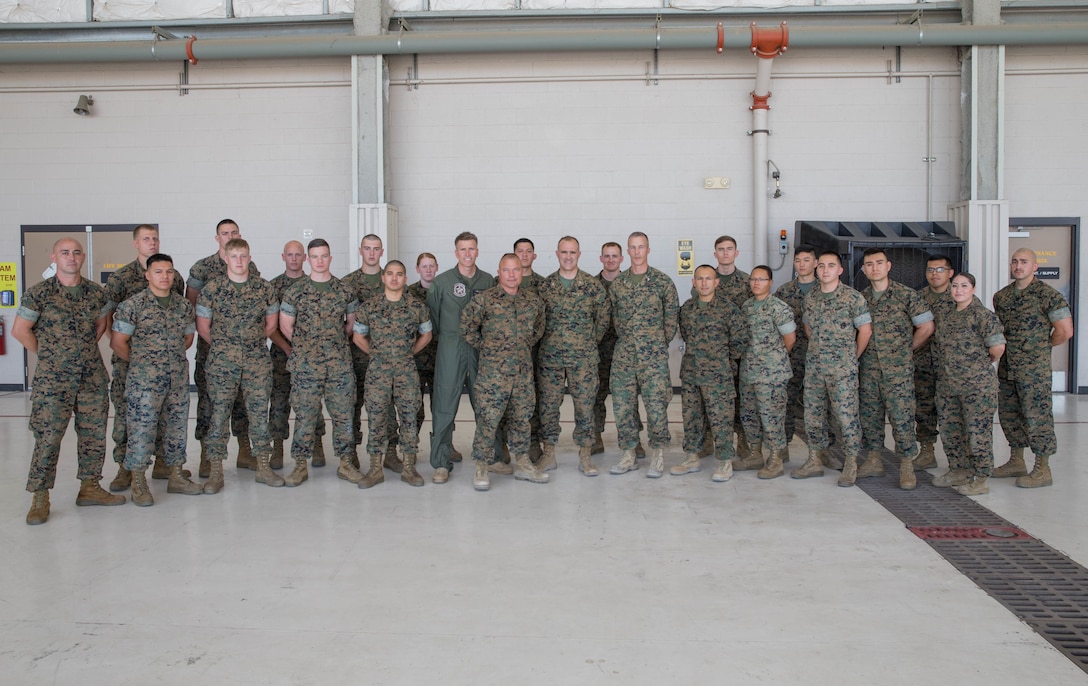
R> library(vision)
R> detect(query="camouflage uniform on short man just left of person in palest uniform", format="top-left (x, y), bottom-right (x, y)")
top-left (678, 294), bottom-right (747, 460)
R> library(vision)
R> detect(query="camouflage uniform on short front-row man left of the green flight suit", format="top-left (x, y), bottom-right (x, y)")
top-left (354, 292), bottom-right (431, 456)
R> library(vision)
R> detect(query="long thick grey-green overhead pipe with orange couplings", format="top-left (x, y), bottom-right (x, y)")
top-left (0, 22), bottom-right (1088, 64)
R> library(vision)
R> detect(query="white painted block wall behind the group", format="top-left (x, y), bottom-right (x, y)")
top-left (0, 49), bottom-right (1088, 391)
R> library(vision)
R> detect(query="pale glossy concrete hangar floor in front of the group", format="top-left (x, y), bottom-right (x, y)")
top-left (0, 394), bottom-right (1088, 686)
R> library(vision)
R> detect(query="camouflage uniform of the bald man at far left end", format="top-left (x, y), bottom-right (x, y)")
top-left (15, 276), bottom-right (110, 492)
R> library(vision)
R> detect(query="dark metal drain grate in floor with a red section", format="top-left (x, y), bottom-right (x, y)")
top-left (826, 451), bottom-right (1088, 673)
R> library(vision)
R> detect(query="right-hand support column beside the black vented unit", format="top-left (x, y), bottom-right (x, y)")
top-left (949, 0), bottom-right (1009, 297)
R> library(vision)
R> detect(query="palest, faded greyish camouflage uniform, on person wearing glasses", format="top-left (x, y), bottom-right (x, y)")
top-left (740, 296), bottom-right (798, 452)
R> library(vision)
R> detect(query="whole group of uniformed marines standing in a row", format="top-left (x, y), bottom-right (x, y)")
top-left (13, 220), bottom-right (1073, 524)
